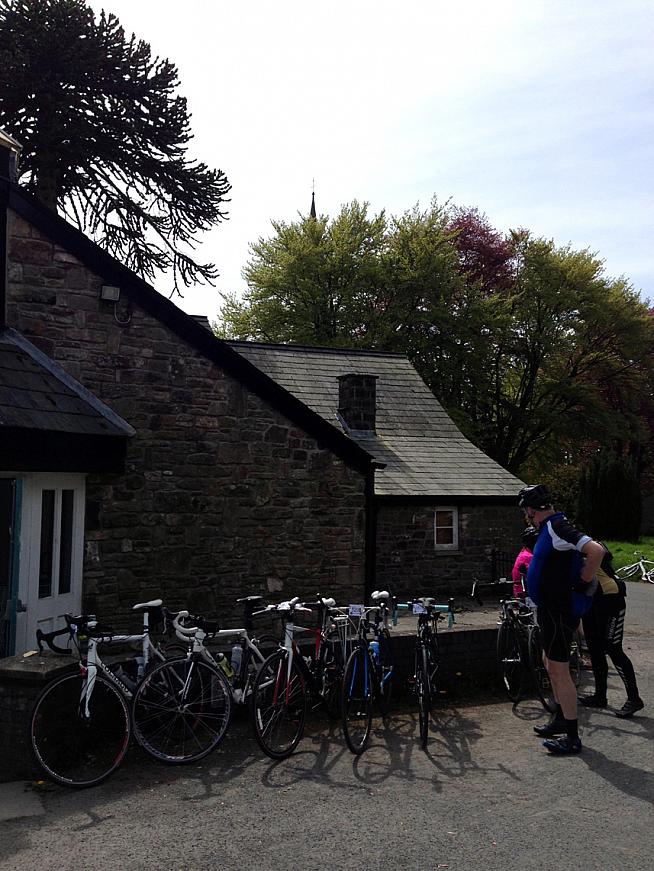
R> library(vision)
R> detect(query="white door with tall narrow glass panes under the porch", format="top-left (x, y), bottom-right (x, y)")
top-left (16, 473), bottom-right (85, 653)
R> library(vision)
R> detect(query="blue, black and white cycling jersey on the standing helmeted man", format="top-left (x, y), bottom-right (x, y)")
top-left (527, 512), bottom-right (591, 614)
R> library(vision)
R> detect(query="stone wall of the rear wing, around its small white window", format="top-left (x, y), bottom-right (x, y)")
top-left (376, 503), bottom-right (524, 597)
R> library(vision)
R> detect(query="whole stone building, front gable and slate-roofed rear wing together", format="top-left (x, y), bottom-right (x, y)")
top-left (0, 136), bottom-right (519, 655)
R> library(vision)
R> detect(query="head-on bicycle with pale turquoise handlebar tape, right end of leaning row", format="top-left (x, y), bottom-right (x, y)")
top-left (397, 596), bottom-right (454, 750)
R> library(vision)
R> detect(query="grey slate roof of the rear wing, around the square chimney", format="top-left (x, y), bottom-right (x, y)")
top-left (229, 342), bottom-right (523, 501)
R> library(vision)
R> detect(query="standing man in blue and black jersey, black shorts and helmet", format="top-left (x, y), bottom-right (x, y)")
top-left (518, 484), bottom-right (605, 755)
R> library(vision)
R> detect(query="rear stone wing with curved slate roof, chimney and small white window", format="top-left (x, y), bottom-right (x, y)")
top-left (230, 342), bottom-right (523, 595)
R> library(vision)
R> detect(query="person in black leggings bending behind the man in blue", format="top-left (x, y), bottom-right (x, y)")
top-left (579, 550), bottom-right (644, 719)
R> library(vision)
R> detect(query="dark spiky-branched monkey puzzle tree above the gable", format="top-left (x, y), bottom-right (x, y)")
top-left (0, 0), bottom-right (230, 290)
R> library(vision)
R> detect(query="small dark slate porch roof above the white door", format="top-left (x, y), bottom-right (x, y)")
top-left (0, 329), bottom-right (135, 437)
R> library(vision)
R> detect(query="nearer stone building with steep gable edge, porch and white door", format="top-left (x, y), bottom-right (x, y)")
top-left (0, 140), bottom-right (375, 654)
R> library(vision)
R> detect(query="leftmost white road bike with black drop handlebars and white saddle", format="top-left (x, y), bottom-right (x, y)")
top-left (30, 599), bottom-right (211, 788)
